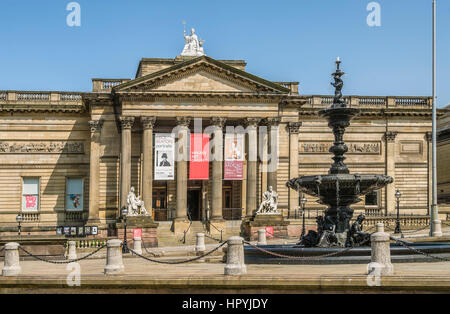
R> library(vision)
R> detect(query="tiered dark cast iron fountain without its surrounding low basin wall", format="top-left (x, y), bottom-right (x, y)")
top-left (286, 58), bottom-right (394, 247)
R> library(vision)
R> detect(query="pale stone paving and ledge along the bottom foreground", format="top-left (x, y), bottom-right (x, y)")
top-left (0, 258), bottom-right (450, 293)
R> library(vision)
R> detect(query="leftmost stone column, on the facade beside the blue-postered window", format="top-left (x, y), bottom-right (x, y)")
top-left (87, 120), bottom-right (103, 225)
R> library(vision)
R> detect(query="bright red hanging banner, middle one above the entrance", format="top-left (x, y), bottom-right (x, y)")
top-left (189, 133), bottom-right (209, 180)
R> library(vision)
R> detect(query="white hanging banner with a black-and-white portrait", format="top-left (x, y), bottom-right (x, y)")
top-left (154, 133), bottom-right (175, 180)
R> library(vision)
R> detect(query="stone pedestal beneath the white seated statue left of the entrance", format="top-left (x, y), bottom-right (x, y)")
top-left (116, 216), bottom-right (158, 248)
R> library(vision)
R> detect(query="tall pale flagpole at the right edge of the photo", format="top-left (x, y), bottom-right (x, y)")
top-left (430, 0), bottom-right (442, 237)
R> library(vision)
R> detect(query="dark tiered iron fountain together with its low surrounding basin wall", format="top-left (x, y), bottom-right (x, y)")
top-left (244, 58), bottom-right (450, 264)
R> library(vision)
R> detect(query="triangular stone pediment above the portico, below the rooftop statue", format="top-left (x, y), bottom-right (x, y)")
top-left (114, 57), bottom-right (289, 95)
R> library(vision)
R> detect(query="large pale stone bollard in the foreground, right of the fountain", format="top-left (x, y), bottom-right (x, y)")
top-left (368, 223), bottom-right (394, 276)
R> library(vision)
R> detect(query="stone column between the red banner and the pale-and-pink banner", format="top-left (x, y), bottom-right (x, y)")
top-left (211, 117), bottom-right (226, 221)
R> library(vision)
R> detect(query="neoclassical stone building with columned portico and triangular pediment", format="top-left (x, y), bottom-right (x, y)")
top-left (0, 52), bottom-right (431, 239)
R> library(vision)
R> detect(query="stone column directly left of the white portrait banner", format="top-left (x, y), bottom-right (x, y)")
top-left (141, 117), bottom-right (156, 215)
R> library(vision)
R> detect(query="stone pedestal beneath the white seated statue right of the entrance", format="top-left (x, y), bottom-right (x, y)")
top-left (242, 214), bottom-right (290, 241)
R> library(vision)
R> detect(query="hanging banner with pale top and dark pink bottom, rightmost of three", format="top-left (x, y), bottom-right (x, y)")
top-left (224, 134), bottom-right (245, 180)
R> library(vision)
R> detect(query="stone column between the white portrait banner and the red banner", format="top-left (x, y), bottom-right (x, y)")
top-left (174, 117), bottom-right (191, 233)
